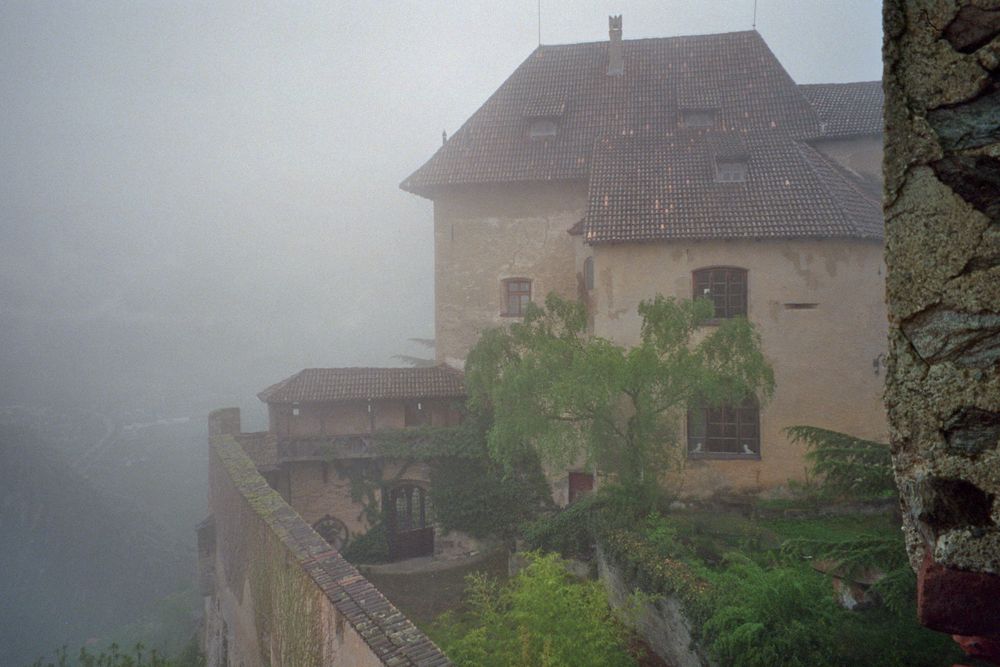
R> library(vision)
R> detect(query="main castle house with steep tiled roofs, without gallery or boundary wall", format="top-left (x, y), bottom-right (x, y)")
top-left (401, 17), bottom-right (887, 493)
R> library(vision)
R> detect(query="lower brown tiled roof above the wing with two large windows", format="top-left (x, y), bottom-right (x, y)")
top-left (584, 130), bottom-right (882, 243)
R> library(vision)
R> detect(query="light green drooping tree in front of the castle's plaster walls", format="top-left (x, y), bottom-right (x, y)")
top-left (466, 294), bottom-right (774, 496)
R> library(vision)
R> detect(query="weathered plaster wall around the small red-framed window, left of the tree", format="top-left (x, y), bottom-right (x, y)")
top-left (434, 182), bottom-right (587, 368)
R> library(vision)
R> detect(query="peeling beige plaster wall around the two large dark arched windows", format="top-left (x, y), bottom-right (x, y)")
top-left (590, 240), bottom-right (887, 495)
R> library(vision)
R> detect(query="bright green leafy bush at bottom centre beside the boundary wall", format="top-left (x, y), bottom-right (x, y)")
top-left (432, 554), bottom-right (635, 667)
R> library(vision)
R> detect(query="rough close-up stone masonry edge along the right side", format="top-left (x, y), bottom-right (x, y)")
top-left (884, 0), bottom-right (1000, 661)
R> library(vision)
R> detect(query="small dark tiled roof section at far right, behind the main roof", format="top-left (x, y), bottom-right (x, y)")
top-left (799, 81), bottom-right (885, 137)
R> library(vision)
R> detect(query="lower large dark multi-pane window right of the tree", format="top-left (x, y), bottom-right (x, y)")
top-left (687, 398), bottom-right (760, 458)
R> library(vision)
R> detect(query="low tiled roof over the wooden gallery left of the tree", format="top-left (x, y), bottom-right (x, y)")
top-left (257, 365), bottom-right (465, 403)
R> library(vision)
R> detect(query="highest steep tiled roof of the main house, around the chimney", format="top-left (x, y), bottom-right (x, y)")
top-left (401, 31), bottom-right (819, 196)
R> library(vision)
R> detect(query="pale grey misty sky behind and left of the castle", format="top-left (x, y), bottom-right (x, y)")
top-left (0, 0), bottom-right (881, 418)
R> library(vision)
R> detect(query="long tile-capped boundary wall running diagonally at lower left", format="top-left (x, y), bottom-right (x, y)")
top-left (199, 412), bottom-right (450, 667)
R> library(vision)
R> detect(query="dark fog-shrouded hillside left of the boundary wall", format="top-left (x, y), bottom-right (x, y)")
top-left (0, 423), bottom-right (194, 665)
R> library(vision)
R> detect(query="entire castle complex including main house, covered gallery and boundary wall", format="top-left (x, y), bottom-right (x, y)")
top-left (198, 17), bottom-right (887, 667)
